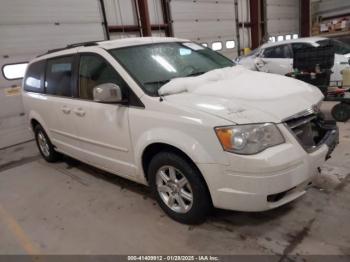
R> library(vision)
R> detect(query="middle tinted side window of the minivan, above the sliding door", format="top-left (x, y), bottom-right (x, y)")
top-left (45, 56), bottom-right (74, 97)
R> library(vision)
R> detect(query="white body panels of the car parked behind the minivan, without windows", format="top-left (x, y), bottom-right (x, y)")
top-left (237, 37), bottom-right (350, 83)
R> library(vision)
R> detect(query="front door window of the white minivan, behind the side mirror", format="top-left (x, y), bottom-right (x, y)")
top-left (79, 55), bottom-right (127, 100)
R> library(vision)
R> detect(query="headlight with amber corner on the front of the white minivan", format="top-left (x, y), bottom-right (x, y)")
top-left (215, 123), bottom-right (285, 155)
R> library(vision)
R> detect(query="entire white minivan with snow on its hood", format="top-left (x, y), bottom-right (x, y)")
top-left (23, 38), bottom-right (338, 224)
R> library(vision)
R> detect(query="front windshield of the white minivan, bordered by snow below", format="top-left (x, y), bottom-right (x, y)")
top-left (110, 42), bottom-right (234, 96)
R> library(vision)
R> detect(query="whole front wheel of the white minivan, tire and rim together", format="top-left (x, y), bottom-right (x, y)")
top-left (148, 152), bottom-right (212, 224)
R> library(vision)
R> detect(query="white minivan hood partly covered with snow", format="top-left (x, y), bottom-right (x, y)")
top-left (159, 66), bottom-right (323, 124)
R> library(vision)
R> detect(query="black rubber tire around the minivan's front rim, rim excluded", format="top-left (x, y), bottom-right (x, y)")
top-left (148, 152), bottom-right (212, 225)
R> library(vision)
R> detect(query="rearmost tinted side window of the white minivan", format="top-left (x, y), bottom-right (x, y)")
top-left (24, 61), bottom-right (45, 93)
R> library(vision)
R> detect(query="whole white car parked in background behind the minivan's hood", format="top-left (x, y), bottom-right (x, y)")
top-left (235, 37), bottom-right (350, 84)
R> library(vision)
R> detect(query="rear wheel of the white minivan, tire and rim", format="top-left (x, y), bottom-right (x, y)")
top-left (34, 124), bottom-right (61, 163)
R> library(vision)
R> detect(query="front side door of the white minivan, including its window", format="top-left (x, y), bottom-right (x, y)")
top-left (72, 53), bottom-right (136, 177)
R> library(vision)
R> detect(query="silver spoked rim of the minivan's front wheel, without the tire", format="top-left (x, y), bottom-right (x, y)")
top-left (156, 166), bottom-right (193, 213)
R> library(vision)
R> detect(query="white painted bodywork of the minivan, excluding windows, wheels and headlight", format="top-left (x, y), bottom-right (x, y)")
top-left (23, 38), bottom-right (336, 214)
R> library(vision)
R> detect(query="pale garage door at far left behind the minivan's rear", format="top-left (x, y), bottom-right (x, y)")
top-left (0, 0), bottom-right (105, 148)
